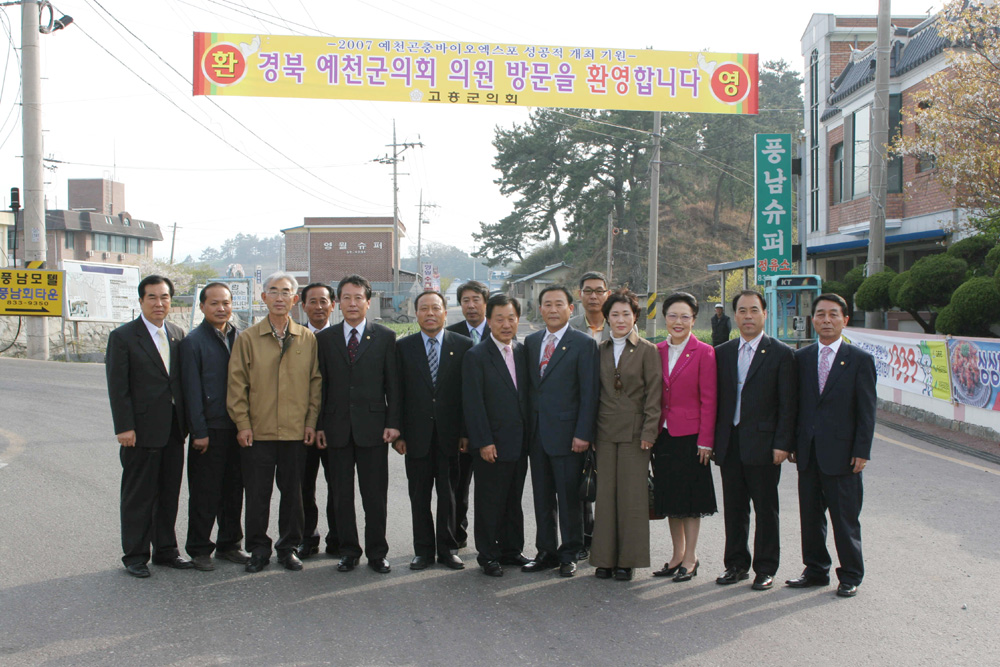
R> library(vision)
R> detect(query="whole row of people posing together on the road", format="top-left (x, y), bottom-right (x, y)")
top-left (107, 272), bottom-right (875, 597)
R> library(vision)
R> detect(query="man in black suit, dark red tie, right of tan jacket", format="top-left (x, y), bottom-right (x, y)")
top-left (317, 275), bottom-right (400, 574)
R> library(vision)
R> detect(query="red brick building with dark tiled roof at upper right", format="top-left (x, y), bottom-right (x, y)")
top-left (801, 14), bottom-right (964, 280)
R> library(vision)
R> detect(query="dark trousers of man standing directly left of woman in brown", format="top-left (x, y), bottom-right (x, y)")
top-left (530, 438), bottom-right (584, 563)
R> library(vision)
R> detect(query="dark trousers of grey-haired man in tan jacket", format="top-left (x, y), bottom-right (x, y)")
top-left (240, 440), bottom-right (306, 558)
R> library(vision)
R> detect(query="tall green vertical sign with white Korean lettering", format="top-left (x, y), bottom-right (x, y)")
top-left (753, 134), bottom-right (792, 285)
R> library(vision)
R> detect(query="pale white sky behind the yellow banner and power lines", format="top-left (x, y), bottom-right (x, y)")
top-left (0, 0), bottom-right (942, 260)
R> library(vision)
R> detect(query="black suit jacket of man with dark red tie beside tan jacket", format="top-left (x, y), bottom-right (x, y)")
top-left (316, 321), bottom-right (401, 448)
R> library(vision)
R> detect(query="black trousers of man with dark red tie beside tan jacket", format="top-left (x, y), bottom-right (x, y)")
top-left (327, 435), bottom-right (389, 560)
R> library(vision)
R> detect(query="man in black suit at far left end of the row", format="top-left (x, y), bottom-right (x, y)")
top-left (105, 275), bottom-right (193, 577)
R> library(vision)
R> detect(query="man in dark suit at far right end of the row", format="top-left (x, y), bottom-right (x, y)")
top-left (785, 294), bottom-right (877, 597)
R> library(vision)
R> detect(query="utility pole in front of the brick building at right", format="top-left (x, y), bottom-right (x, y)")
top-left (865, 0), bottom-right (891, 329)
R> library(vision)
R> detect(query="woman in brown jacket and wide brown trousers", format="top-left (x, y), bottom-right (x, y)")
top-left (590, 288), bottom-right (663, 581)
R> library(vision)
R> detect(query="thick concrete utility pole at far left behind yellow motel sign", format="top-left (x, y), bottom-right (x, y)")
top-left (21, 0), bottom-right (49, 360)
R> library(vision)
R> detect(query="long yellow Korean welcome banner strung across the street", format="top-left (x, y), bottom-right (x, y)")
top-left (194, 32), bottom-right (757, 114)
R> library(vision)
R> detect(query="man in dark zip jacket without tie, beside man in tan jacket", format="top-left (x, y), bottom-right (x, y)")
top-left (180, 283), bottom-right (250, 570)
